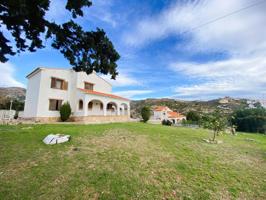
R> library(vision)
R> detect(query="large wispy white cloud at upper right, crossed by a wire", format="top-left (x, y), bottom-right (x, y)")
top-left (124, 0), bottom-right (266, 54)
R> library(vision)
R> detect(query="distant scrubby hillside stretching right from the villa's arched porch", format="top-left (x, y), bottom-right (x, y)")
top-left (131, 97), bottom-right (249, 117)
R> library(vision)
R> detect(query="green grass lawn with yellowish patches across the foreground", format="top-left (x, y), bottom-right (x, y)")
top-left (0, 123), bottom-right (266, 200)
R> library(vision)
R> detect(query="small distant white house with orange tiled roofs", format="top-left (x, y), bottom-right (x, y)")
top-left (152, 106), bottom-right (186, 124)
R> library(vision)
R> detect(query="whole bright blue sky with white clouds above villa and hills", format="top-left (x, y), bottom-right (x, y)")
top-left (0, 0), bottom-right (266, 100)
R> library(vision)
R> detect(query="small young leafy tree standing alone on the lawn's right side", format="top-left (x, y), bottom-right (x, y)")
top-left (201, 110), bottom-right (228, 141)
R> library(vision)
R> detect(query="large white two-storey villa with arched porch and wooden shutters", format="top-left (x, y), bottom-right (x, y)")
top-left (23, 67), bottom-right (130, 123)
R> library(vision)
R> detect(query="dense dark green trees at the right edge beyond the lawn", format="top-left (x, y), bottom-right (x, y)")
top-left (231, 108), bottom-right (266, 133)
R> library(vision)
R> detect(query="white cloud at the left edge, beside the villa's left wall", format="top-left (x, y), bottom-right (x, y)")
top-left (0, 62), bottom-right (25, 87)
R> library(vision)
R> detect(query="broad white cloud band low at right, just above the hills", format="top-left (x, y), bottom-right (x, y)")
top-left (171, 56), bottom-right (266, 99)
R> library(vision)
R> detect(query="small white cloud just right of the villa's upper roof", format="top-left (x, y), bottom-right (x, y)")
top-left (101, 72), bottom-right (141, 87)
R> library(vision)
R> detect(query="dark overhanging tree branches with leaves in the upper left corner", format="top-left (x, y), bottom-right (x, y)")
top-left (0, 0), bottom-right (120, 79)
